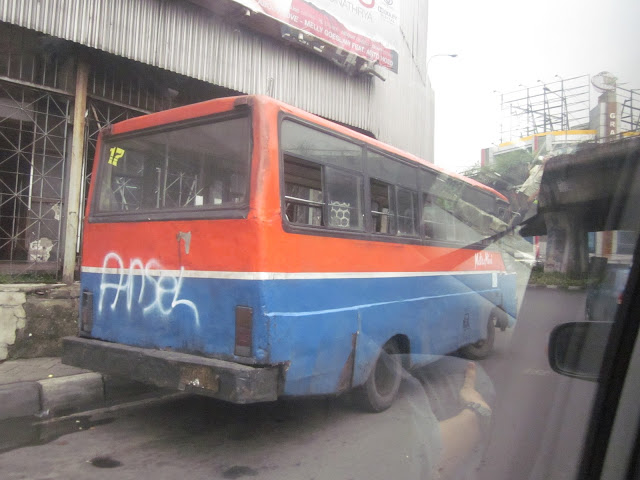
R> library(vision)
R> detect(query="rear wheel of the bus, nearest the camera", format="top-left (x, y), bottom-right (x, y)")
top-left (355, 340), bottom-right (402, 412)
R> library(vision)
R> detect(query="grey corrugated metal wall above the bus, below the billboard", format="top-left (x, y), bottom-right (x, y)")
top-left (0, 0), bottom-right (431, 157)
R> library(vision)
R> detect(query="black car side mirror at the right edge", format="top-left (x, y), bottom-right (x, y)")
top-left (549, 322), bottom-right (613, 382)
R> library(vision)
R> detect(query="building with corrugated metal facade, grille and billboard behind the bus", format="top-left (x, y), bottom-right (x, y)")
top-left (0, 0), bottom-right (433, 281)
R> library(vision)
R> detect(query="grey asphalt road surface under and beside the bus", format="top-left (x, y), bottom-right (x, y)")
top-left (0, 289), bottom-right (594, 480)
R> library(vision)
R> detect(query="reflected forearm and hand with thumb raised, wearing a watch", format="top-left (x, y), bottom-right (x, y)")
top-left (438, 363), bottom-right (490, 478)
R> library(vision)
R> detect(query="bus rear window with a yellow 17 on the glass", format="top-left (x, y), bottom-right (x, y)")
top-left (96, 117), bottom-right (251, 215)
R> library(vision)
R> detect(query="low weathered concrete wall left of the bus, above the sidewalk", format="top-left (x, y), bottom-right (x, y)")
top-left (0, 284), bottom-right (80, 361)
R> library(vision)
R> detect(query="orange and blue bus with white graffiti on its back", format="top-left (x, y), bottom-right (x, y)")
top-left (63, 96), bottom-right (516, 411)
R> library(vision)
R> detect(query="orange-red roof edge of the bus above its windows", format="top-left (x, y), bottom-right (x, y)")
top-left (111, 95), bottom-right (509, 203)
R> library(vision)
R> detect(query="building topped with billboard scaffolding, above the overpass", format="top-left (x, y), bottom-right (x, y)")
top-left (480, 72), bottom-right (640, 166)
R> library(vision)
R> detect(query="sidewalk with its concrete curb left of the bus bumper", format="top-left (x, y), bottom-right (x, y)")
top-left (0, 357), bottom-right (161, 421)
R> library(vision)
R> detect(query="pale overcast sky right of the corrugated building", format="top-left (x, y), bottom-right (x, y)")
top-left (427, 0), bottom-right (640, 171)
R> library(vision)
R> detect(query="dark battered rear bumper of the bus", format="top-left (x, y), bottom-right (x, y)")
top-left (62, 337), bottom-right (280, 403)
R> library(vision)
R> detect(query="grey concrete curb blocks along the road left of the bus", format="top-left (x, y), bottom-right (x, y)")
top-left (0, 372), bottom-right (168, 421)
